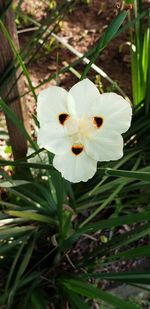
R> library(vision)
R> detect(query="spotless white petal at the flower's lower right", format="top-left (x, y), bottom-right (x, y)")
top-left (85, 130), bottom-right (123, 161)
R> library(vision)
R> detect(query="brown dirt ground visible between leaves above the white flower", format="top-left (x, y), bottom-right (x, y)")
top-left (19, 0), bottom-right (131, 109)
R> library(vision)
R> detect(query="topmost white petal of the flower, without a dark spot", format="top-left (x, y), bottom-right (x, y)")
top-left (69, 79), bottom-right (100, 116)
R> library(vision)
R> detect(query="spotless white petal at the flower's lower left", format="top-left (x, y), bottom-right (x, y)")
top-left (37, 122), bottom-right (72, 154)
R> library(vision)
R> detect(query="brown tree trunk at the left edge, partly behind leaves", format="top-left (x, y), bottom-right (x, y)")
top-left (0, 0), bottom-right (29, 160)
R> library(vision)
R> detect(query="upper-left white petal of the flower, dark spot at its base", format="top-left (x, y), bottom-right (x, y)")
top-left (37, 86), bottom-right (73, 126)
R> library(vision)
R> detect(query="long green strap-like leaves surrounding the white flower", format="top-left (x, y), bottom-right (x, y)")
top-left (0, 1), bottom-right (150, 309)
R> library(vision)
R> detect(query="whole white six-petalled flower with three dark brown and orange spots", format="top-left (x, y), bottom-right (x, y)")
top-left (37, 79), bottom-right (132, 182)
